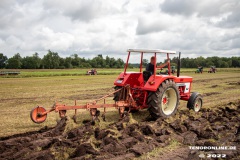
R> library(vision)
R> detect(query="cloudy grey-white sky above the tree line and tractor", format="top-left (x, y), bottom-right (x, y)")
top-left (0, 0), bottom-right (240, 61)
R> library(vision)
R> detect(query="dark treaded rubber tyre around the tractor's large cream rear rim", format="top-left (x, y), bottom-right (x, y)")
top-left (147, 80), bottom-right (180, 119)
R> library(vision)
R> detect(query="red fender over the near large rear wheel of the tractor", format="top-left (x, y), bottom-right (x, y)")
top-left (144, 75), bottom-right (174, 92)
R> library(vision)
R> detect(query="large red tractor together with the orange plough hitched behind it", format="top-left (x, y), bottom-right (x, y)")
top-left (30, 49), bottom-right (203, 123)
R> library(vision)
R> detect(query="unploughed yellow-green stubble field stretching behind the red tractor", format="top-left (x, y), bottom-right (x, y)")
top-left (0, 69), bottom-right (240, 137)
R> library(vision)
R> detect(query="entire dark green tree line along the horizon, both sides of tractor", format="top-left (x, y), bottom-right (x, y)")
top-left (0, 50), bottom-right (240, 69)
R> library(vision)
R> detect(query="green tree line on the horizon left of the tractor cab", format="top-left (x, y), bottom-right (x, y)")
top-left (0, 50), bottom-right (124, 69)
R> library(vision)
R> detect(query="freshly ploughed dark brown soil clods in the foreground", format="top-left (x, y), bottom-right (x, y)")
top-left (0, 101), bottom-right (240, 160)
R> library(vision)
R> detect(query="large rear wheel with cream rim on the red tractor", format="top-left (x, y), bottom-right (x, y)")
top-left (147, 80), bottom-right (179, 119)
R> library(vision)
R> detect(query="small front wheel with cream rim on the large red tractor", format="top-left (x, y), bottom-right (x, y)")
top-left (187, 92), bottom-right (203, 112)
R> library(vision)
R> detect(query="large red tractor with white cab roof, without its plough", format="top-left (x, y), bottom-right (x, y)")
top-left (114, 49), bottom-right (202, 119)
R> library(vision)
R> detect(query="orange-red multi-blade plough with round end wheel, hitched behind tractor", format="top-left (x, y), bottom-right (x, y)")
top-left (30, 85), bottom-right (136, 123)
